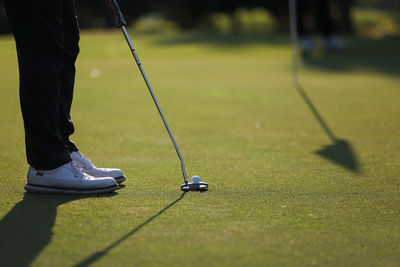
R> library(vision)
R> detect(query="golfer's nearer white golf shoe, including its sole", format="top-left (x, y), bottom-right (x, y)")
top-left (25, 162), bottom-right (118, 194)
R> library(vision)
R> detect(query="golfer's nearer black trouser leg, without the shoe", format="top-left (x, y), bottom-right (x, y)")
top-left (5, 0), bottom-right (77, 170)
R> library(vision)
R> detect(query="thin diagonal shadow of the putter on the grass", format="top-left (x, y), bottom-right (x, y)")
top-left (74, 192), bottom-right (186, 267)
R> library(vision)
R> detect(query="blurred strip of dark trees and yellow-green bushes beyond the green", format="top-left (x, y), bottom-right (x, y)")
top-left (0, 0), bottom-right (400, 38)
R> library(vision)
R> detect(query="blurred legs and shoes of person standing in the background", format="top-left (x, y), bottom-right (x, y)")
top-left (297, 0), bottom-right (345, 51)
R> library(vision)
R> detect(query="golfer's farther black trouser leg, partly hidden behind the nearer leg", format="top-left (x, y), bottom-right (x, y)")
top-left (59, 0), bottom-right (79, 152)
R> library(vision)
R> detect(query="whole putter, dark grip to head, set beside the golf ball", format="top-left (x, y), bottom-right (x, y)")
top-left (105, 0), bottom-right (208, 191)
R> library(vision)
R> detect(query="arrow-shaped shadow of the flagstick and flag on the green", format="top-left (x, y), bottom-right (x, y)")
top-left (295, 83), bottom-right (359, 172)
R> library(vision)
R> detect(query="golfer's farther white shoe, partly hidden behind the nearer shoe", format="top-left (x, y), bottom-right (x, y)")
top-left (71, 151), bottom-right (126, 184)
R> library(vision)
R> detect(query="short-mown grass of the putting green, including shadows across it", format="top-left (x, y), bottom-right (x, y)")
top-left (0, 32), bottom-right (400, 266)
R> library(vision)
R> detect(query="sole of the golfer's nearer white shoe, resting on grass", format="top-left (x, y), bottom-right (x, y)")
top-left (24, 184), bottom-right (119, 195)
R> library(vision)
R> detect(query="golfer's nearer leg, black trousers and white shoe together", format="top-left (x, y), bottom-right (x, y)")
top-left (5, 0), bottom-right (118, 194)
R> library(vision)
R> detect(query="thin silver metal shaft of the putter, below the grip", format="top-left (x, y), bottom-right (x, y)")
top-left (121, 25), bottom-right (188, 184)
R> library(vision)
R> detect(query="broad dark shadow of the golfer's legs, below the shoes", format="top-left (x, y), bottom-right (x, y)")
top-left (0, 193), bottom-right (116, 266)
